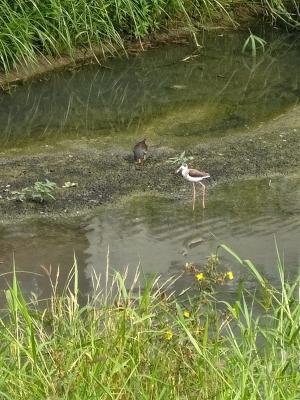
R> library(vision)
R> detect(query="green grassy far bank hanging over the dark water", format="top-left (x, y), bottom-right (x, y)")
top-left (0, 0), bottom-right (300, 72)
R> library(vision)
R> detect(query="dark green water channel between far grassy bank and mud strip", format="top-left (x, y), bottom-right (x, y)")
top-left (0, 33), bottom-right (300, 147)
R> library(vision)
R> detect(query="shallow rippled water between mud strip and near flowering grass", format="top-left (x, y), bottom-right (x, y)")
top-left (0, 175), bottom-right (300, 304)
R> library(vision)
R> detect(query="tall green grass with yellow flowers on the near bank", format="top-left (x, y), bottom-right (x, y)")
top-left (0, 245), bottom-right (300, 400)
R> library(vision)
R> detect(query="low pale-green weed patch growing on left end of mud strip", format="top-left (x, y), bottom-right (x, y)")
top-left (11, 179), bottom-right (57, 203)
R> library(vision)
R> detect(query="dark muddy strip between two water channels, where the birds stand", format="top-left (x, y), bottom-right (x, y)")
top-left (0, 107), bottom-right (300, 221)
